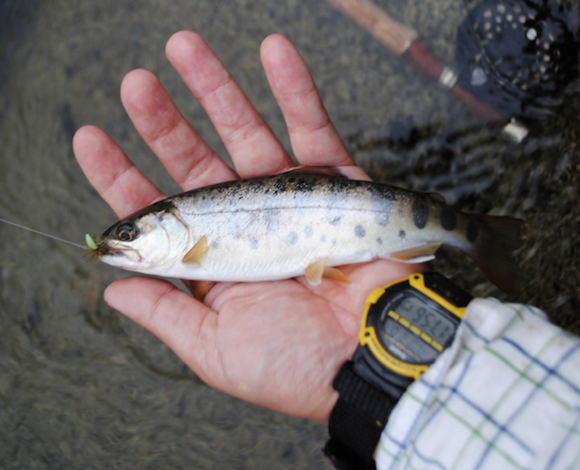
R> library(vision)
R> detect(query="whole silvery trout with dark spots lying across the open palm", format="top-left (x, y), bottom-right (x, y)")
top-left (87, 168), bottom-right (525, 292)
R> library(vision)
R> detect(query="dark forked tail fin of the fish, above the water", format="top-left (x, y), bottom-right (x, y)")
top-left (468, 215), bottom-right (528, 294)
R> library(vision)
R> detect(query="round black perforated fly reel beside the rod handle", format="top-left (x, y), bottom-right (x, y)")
top-left (456, 0), bottom-right (580, 120)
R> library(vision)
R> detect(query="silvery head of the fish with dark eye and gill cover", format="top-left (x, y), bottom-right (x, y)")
top-left (93, 210), bottom-right (190, 273)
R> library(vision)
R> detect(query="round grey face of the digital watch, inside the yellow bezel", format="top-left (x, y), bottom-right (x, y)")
top-left (377, 291), bottom-right (455, 364)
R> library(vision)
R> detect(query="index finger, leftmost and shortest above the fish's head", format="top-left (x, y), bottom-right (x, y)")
top-left (73, 126), bottom-right (165, 218)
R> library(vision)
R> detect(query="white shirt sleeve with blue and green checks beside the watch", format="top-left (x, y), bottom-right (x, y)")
top-left (376, 299), bottom-right (580, 470)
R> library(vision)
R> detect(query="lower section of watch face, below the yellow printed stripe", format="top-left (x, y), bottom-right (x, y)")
top-left (381, 318), bottom-right (438, 364)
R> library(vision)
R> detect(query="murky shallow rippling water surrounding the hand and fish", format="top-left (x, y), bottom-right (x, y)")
top-left (0, 0), bottom-right (580, 469)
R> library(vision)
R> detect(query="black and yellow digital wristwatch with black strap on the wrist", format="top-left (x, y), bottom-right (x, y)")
top-left (324, 272), bottom-right (473, 470)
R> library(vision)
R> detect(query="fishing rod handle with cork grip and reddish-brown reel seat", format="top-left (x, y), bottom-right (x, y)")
top-left (327, 0), bottom-right (528, 142)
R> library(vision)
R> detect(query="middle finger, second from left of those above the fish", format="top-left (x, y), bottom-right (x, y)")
top-left (121, 69), bottom-right (237, 190)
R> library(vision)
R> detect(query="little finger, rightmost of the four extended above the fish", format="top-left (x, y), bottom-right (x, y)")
top-left (260, 34), bottom-right (355, 171)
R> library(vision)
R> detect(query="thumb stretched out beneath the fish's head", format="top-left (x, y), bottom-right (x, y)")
top-left (105, 277), bottom-right (222, 386)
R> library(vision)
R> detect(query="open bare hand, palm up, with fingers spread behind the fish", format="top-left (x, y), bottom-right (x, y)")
top-left (73, 31), bottom-right (418, 422)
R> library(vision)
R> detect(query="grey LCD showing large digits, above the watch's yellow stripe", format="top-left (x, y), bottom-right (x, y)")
top-left (394, 296), bottom-right (455, 346)
